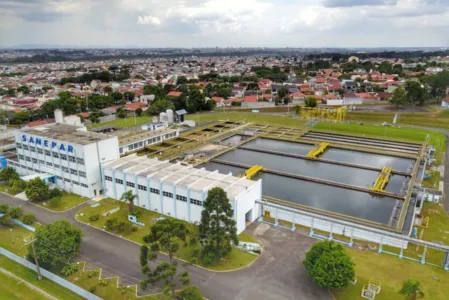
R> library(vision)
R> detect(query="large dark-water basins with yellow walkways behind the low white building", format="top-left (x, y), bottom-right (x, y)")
top-left (204, 138), bottom-right (416, 225)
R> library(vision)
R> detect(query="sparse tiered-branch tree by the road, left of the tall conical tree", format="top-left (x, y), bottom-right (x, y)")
top-left (140, 218), bottom-right (190, 299)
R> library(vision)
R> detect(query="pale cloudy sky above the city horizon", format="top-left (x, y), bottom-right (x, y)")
top-left (0, 0), bottom-right (449, 48)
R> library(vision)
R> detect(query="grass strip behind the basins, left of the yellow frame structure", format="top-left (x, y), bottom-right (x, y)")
top-left (187, 111), bottom-right (306, 127)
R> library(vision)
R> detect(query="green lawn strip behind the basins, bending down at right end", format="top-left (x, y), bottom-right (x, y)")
top-left (313, 122), bottom-right (446, 164)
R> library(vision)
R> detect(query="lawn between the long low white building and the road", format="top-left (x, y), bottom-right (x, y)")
top-left (77, 199), bottom-right (256, 271)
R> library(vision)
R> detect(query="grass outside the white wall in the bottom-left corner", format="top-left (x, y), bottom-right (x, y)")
top-left (0, 255), bottom-right (83, 300)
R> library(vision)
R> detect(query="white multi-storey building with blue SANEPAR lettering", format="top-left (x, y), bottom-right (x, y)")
top-left (7, 123), bottom-right (120, 197)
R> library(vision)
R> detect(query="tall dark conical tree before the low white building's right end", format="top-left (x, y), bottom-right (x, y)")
top-left (199, 187), bottom-right (239, 264)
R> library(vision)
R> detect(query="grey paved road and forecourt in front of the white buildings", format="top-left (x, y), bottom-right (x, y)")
top-left (0, 194), bottom-right (331, 300)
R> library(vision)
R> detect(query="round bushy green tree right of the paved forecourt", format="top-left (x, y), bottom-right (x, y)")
top-left (304, 241), bottom-right (355, 288)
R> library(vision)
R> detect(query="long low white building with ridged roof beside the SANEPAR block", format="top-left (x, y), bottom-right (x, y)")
top-left (102, 155), bottom-right (262, 233)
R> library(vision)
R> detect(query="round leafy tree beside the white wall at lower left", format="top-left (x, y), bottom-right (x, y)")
top-left (27, 220), bottom-right (83, 271)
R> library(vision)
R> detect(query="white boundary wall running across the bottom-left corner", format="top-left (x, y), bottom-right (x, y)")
top-left (0, 248), bottom-right (102, 300)
